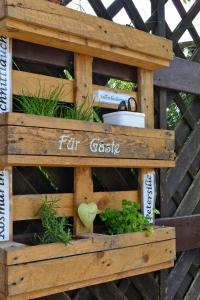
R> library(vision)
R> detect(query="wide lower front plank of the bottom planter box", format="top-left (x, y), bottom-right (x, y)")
top-left (8, 241), bottom-right (174, 295)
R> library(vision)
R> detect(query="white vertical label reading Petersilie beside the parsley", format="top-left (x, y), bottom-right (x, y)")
top-left (142, 171), bottom-right (156, 223)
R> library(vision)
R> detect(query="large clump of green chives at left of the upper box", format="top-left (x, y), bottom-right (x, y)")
top-left (15, 86), bottom-right (63, 117)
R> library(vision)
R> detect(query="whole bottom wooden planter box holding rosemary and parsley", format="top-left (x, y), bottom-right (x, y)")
top-left (0, 227), bottom-right (175, 300)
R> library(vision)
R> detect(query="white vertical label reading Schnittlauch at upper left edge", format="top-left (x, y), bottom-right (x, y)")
top-left (0, 36), bottom-right (12, 113)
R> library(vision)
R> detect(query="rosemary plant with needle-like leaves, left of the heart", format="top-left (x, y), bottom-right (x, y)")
top-left (38, 199), bottom-right (72, 245)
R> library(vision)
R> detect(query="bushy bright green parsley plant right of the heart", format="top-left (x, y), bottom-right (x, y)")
top-left (100, 199), bottom-right (153, 235)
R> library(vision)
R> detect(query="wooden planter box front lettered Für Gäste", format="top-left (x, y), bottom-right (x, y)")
top-left (0, 113), bottom-right (175, 167)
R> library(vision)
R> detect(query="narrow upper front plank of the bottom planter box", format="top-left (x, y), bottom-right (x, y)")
top-left (0, 227), bottom-right (175, 265)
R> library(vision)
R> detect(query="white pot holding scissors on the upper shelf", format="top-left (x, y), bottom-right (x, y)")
top-left (103, 111), bottom-right (145, 128)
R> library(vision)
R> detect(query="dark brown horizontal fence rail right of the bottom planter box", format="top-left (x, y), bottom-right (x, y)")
top-left (156, 215), bottom-right (200, 251)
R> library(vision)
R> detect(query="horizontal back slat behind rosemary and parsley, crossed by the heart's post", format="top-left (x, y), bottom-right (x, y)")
top-left (13, 191), bottom-right (139, 221)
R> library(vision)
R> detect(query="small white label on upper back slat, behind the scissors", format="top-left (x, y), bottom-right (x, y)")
top-left (94, 90), bottom-right (130, 105)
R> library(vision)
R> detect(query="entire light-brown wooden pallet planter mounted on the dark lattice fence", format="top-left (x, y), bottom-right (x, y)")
top-left (0, 0), bottom-right (175, 300)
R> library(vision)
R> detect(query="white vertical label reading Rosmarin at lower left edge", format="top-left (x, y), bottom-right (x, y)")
top-left (0, 170), bottom-right (10, 242)
